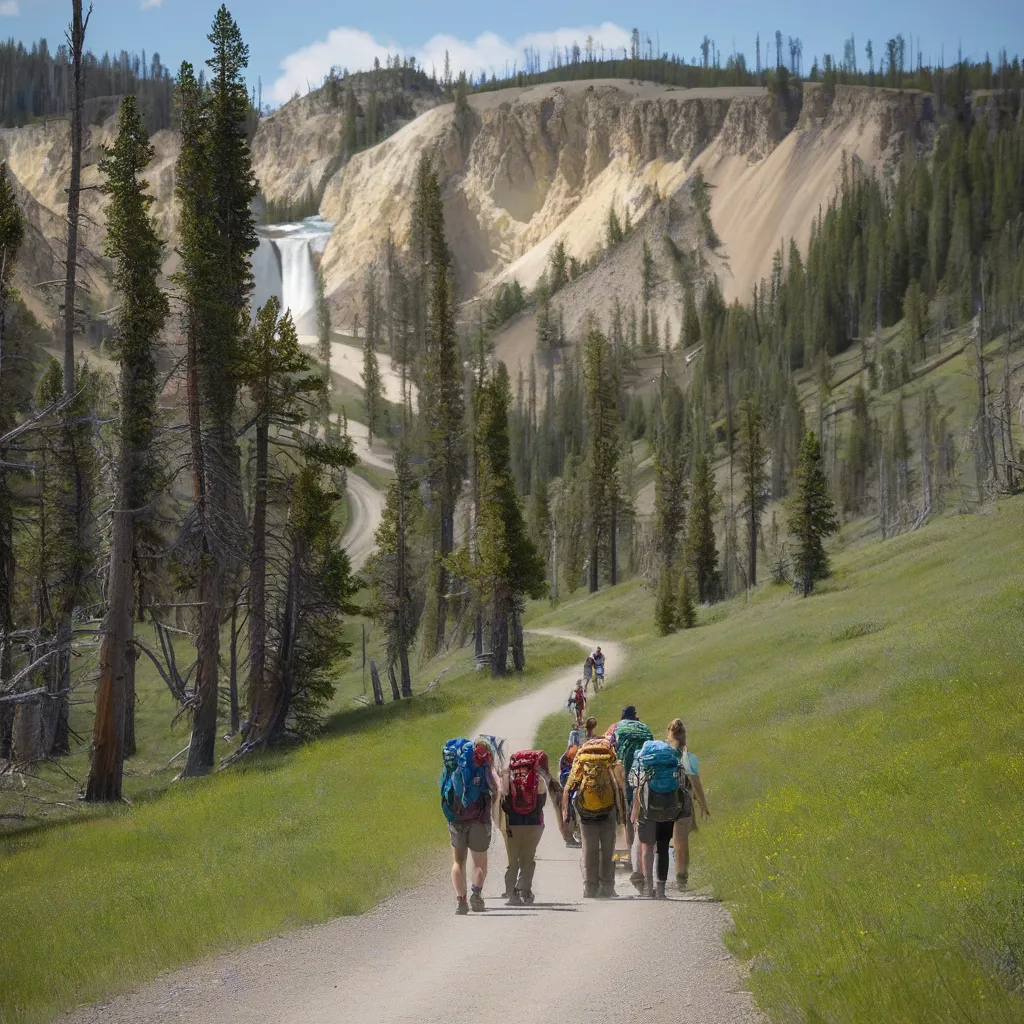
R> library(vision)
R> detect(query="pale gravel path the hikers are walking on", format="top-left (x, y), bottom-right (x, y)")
top-left (66, 631), bottom-right (763, 1024)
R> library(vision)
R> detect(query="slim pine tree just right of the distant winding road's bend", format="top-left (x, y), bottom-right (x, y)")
top-left (364, 439), bottom-right (422, 697)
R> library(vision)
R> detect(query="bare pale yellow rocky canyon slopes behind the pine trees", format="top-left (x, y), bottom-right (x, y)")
top-left (0, 81), bottom-right (934, 348)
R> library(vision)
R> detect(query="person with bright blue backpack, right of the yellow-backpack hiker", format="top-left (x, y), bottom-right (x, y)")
top-left (631, 739), bottom-right (693, 899)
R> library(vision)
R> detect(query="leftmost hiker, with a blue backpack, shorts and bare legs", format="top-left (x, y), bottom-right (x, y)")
top-left (440, 736), bottom-right (501, 914)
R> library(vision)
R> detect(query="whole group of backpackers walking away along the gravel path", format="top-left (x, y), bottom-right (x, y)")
top-left (440, 648), bottom-right (711, 914)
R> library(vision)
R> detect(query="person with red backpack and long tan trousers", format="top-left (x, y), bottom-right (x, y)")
top-left (502, 751), bottom-right (564, 906)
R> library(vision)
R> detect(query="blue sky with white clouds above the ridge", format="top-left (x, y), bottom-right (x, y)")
top-left (0, 0), bottom-right (1024, 105)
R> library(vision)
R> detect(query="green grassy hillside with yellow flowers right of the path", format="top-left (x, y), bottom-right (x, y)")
top-left (538, 499), bottom-right (1024, 1024)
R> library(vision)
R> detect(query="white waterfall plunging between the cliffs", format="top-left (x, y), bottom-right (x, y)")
top-left (252, 217), bottom-right (334, 334)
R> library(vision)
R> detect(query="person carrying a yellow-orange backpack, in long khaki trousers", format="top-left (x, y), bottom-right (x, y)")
top-left (562, 739), bottom-right (626, 899)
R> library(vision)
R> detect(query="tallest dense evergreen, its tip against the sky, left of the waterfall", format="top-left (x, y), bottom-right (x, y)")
top-left (175, 6), bottom-right (257, 775)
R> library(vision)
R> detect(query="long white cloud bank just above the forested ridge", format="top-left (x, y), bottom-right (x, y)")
top-left (270, 22), bottom-right (630, 103)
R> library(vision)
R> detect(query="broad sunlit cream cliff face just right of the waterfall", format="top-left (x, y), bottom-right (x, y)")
top-left (321, 82), bottom-right (781, 321)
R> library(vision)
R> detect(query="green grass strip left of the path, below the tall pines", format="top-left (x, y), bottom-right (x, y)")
top-left (0, 637), bottom-right (579, 1022)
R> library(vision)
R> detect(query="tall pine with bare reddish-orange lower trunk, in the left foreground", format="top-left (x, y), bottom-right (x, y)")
top-left (85, 96), bottom-right (169, 801)
